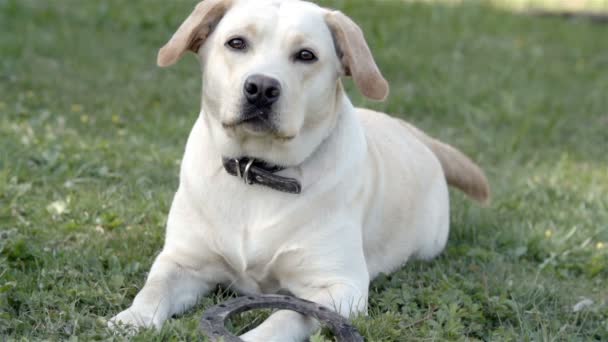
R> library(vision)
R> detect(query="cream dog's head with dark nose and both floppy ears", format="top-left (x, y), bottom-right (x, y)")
top-left (158, 0), bottom-right (388, 166)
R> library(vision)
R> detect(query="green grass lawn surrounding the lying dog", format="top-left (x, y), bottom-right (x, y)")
top-left (0, 0), bottom-right (608, 341)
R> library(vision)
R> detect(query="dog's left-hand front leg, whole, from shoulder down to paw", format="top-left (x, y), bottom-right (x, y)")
top-left (108, 190), bottom-right (227, 329)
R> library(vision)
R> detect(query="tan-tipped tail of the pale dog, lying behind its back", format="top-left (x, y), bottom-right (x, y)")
top-left (399, 120), bottom-right (490, 205)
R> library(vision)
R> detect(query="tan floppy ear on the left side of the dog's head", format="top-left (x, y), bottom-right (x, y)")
top-left (157, 0), bottom-right (232, 67)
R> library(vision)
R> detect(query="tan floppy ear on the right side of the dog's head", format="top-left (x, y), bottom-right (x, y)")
top-left (325, 11), bottom-right (389, 101)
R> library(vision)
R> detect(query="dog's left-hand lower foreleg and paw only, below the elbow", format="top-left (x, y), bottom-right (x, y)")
top-left (109, 252), bottom-right (213, 329)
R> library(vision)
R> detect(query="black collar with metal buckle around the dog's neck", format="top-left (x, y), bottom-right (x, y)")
top-left (222, 157), bottom-right (302, 194)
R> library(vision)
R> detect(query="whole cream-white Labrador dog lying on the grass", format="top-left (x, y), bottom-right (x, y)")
top-left (110, 0), bottom-right (489, 342)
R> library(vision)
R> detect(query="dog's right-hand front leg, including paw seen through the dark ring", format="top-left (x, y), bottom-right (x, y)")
top-left (241, 226), bottom-right (369, 342)
